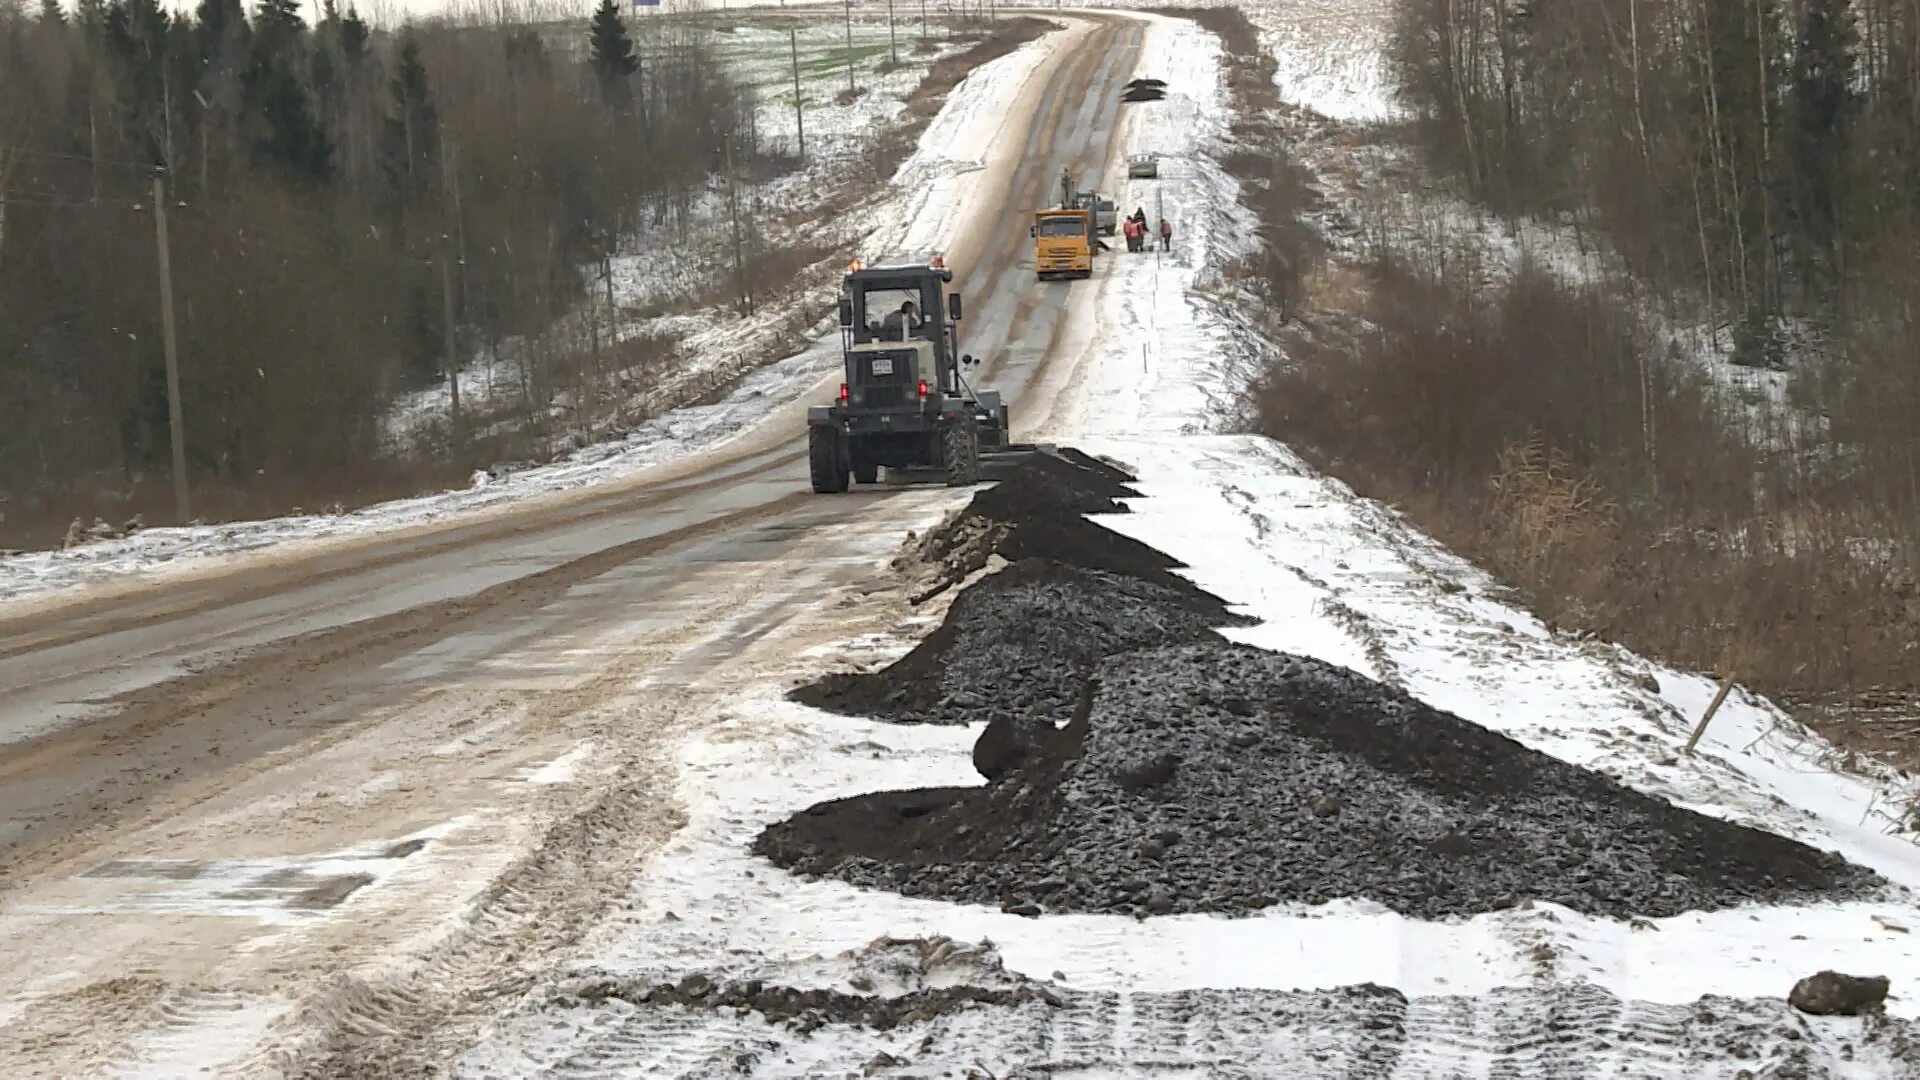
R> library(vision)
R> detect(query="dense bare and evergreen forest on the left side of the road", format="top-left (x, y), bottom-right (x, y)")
top-left (0, 0), bottom-right (753, 546)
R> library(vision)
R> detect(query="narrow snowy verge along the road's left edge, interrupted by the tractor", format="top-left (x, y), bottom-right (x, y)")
top-left (0, 29), bottom-right (1050, 603)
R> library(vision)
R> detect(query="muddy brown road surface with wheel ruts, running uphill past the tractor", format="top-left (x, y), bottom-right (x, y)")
top-left (0, 15), bottom-right (1144, 1074)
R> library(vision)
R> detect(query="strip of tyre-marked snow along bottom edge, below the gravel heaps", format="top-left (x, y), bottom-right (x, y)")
top-left (455, 986), bottom-right (1914, 1080)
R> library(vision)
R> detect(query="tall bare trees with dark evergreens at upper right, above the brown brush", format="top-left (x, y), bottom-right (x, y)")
top-left (1392, 0), bottom-right (1920, 552)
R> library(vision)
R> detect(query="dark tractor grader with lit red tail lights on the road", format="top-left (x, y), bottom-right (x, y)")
top-left (806, 256), bottom-right (1006, 492)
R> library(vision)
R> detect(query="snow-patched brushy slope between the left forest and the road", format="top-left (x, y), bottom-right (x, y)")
top-left (388, 19), bottom-right (972, 452)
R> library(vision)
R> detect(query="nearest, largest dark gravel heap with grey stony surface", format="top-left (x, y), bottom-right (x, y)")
top-left (756, 642), bottom-right (1882, 919)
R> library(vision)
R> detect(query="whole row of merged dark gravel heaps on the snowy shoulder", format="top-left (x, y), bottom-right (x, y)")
top-left (755, 447), bottom-right (1885, 919)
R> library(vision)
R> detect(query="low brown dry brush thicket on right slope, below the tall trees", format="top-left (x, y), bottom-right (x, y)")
top-left (1256, 253), bottom-right (1920, 746)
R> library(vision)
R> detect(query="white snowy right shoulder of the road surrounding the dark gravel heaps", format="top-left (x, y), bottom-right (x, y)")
top-left (445, 6), bottom-right (1920, 1076)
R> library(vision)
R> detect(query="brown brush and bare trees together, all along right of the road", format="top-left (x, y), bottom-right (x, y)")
top-left (1254, 0), bottom-right (1920, 722)
